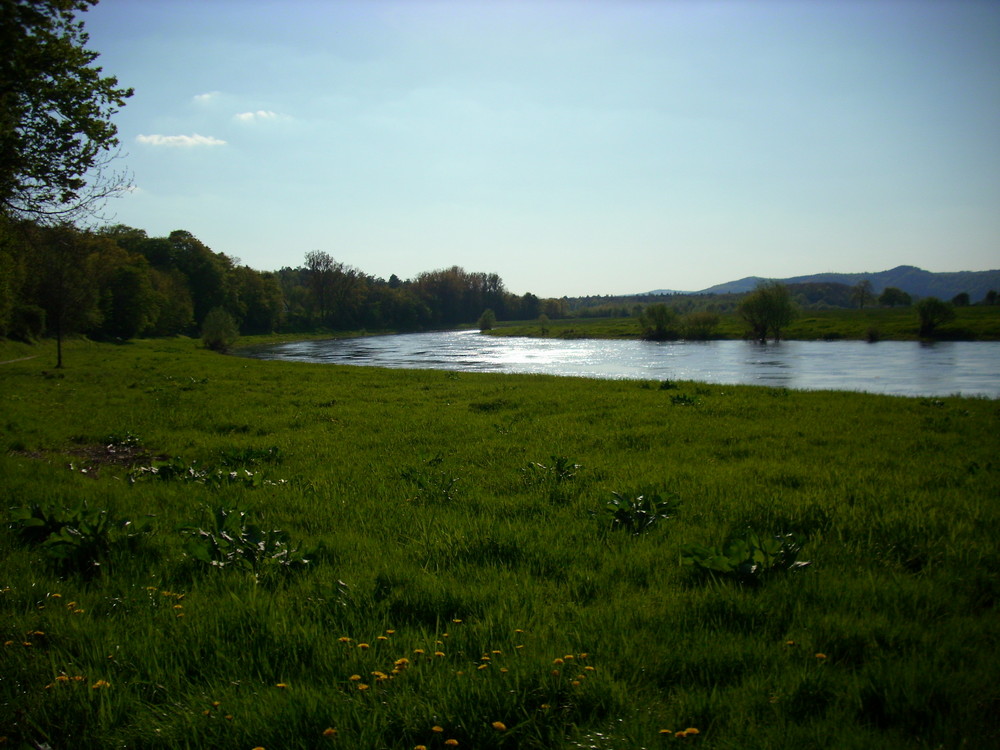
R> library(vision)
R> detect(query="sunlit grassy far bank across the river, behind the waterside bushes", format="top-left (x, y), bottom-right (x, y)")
top-left (491, 307), bottom-right (1000, 341)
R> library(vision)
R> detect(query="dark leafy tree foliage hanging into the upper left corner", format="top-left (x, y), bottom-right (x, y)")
top-left (0, 0), bottom-right (132, 221)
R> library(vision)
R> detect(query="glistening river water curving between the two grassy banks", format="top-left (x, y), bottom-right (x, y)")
top-left (246, 331), bottom-right (1000, 398)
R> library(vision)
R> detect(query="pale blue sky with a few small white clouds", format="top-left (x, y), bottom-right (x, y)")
top-left (81, 0), bottom-right (1000, 297)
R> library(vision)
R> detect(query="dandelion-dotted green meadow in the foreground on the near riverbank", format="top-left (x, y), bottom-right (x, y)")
top-left (0, 338), bottom-right (1000, 750)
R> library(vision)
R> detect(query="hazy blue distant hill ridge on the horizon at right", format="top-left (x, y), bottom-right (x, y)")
top-left (650, 266), bottom-right (1000, 302)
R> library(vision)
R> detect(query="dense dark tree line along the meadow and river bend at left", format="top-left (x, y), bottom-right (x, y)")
top-left (0, 221), bottom-right (559, 340)
